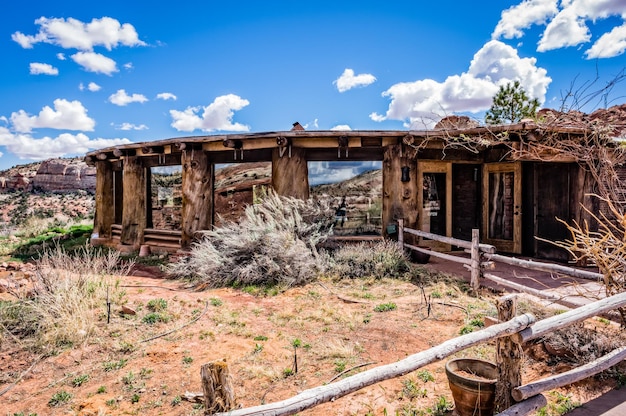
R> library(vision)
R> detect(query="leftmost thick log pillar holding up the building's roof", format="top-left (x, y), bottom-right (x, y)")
top-left (93, 160), bottom-right (115, 239)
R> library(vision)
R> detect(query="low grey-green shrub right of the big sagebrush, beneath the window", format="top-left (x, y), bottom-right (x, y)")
top-left (328, 240), bottom-right (410, 279)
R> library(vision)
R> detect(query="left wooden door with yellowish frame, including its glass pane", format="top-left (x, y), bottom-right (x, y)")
top-left (417, 162), bottom-right (452, 251)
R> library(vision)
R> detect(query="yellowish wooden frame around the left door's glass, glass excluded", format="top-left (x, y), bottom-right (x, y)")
top-left (417, 161), bottom-right (452, 251)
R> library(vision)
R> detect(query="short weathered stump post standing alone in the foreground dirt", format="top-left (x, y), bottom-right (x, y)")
top-left (200, 359), bottom-right (236, 415)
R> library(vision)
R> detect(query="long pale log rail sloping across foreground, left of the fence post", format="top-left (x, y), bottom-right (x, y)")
top-left (216, 314), bottom-right (535, 416)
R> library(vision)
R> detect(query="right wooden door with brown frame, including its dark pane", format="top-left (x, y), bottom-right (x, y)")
top-left (482, 162), bottom-right (522, 254)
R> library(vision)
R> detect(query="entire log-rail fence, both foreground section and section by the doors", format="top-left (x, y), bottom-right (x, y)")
top-left (211, 223), bottom-right (626, 416)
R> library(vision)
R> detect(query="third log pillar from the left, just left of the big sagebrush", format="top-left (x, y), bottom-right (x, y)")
top-left (181, 149), bottom-right (214, 248)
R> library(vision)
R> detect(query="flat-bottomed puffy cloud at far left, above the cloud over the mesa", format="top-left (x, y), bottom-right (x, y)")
top-left (11, 98), bottom-right (96, 133)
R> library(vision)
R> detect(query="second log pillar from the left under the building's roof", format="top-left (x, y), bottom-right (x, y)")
top-left (120, 156), bottom-right (146, 249)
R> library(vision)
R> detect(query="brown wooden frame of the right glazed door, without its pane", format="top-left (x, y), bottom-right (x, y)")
top-left (482, 162), bottom-right (522, 254)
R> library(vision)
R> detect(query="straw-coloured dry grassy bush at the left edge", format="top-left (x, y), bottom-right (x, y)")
top-left (0, 246), bottom-right (132, 354)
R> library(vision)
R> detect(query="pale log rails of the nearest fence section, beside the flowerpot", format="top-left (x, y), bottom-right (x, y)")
top-left (214, 293), bottom-right (626, 416)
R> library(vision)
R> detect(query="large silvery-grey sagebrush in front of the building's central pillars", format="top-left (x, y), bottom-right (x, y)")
top-left (167, 193), bottom-right (334, 288)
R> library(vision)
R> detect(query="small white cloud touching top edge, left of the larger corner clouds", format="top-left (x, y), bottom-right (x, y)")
top-left (492, 0), bottom-right (559, 39)
